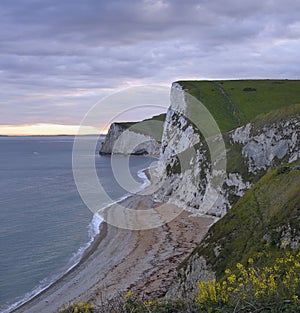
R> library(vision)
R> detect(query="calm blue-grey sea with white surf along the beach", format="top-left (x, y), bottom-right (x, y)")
top-left (0, 136), bottom-right (153, 313)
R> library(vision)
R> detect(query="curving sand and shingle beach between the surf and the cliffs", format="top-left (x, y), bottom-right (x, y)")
top-left (13, 195), bottom-right (214, 313)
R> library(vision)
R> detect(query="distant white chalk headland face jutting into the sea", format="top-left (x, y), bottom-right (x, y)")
top-left (100, 123), bottom-right (160, 156)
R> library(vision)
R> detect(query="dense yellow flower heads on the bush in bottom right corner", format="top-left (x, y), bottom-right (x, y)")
top-left (196, 252), bottom-right (300, 311)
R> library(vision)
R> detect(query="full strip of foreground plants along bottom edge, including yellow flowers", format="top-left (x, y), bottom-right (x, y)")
top-left (60, 247), bottom-right (300, 313)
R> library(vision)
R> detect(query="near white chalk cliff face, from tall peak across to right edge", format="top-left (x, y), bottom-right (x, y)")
top-left (155, 83), bottom-right (300, 217)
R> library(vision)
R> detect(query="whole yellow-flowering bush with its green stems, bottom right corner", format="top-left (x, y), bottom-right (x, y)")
top-left (196, 247), bottom-right (300, 313)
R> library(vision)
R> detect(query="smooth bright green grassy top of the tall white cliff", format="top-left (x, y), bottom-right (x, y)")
top-left (178, 80), bottom-right (300, 132)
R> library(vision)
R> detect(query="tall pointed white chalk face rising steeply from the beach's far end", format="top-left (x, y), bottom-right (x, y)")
top-left (154, 83), bottom-right (223, 215)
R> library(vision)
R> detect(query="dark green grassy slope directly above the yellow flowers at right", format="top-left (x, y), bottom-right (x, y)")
top-left (185, 160), bottom-right (300, 278)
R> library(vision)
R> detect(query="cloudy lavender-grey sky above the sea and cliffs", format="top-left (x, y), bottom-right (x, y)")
top-left (0, 0), bottom-right (300, 134)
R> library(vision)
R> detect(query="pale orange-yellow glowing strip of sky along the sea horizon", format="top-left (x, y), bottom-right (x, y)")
top-left (0, 123), bottom-right (103, 136)
